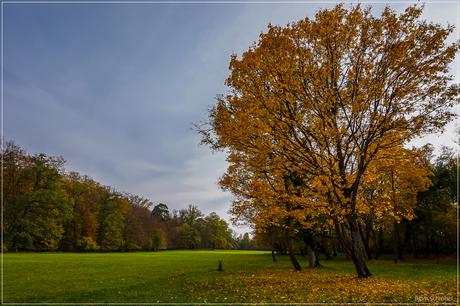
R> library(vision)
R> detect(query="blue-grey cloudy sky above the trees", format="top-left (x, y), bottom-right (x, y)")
top-left (2, 1), bottom-right (458, 232)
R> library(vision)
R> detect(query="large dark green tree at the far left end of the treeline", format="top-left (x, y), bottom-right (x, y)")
top-left (2, 142), bottom-right (71, 251)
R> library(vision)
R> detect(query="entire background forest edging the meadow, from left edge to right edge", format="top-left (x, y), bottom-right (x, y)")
top-left (1, 141), bottom-right (458, 265)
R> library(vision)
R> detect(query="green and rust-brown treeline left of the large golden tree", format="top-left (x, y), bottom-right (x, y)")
top-left (1, 142), bottom-right (245, 251)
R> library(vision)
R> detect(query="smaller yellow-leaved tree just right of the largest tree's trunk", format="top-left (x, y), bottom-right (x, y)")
top-left (356, 147), bottom-right (432, 260)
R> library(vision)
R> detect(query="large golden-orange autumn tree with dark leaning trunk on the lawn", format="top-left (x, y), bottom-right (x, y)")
top-left (200, 5), bottom-right (459, 277)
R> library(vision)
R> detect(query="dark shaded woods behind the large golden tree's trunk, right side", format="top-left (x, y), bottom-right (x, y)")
top-left (254, 147), bottom-right (458, 267)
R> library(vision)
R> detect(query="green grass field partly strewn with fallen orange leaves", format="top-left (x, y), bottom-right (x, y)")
top-left (3, 251), bottom-right (457, 303)
